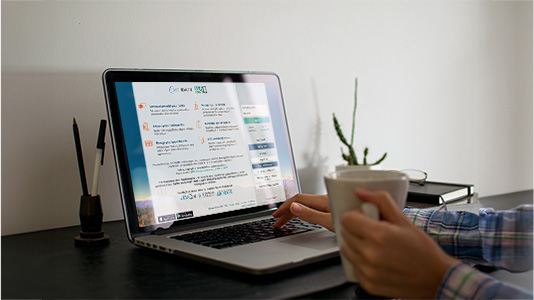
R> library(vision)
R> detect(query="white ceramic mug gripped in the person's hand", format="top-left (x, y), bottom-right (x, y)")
top-left (324, 170), bottom-right (409, 282)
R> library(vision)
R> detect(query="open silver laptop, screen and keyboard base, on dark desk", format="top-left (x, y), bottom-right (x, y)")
top-left (102, 69), bottom-right (339, 274)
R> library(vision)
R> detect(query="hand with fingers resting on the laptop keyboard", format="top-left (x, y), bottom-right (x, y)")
top-left (273, 194), bottom-right (334, 231)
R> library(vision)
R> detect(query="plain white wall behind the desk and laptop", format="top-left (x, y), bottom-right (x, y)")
top-left (2, 0), bottom-right (533, 235)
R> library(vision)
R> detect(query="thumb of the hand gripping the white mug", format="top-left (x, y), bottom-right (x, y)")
top-left (356, 188), bottom-right (406, 225)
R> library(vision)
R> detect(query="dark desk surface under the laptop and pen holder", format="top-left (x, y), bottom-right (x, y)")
top-left (1, 191), bottom-right (532, 299)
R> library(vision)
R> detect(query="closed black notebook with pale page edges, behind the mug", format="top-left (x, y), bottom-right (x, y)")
top-left (407, 181), bottom-right (474, 205)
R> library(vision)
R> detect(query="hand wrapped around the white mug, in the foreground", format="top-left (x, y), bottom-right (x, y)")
top-left (341, 189), bottom-right (459, 299)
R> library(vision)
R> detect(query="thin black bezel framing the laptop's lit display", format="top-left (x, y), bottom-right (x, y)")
top-left (102, 69), bottom-right (300, 240)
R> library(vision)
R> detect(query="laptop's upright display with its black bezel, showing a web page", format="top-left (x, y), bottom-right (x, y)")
top-left (104, 70), bottom-right (299, 232)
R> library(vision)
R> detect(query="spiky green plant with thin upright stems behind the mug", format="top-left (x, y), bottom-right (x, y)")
top-left (332, 78), bottom-right (387, 170)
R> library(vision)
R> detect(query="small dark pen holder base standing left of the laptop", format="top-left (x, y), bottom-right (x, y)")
top-left (74, 195), bottom-right (109, 246)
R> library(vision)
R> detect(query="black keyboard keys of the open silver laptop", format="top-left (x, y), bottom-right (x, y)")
top-left (172, 218), bottom-right (322, 249)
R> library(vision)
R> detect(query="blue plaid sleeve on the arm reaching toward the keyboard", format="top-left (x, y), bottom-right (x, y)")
top-left (403, 205), bottom-right (533, 272)
